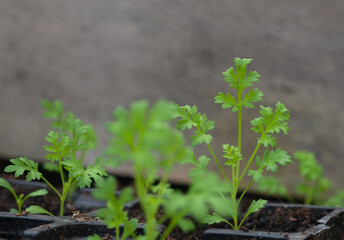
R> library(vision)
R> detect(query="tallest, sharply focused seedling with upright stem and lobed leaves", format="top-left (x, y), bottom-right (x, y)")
top-left (176, 58), bottom-right (291, 229)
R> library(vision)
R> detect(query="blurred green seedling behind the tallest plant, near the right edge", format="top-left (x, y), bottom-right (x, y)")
top-left (257, 151), bottom-right (344, 206)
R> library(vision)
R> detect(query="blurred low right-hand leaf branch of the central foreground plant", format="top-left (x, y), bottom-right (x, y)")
top-left (161, 173), bottom-right (233, 238)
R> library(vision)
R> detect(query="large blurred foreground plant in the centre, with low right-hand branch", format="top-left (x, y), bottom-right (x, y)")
top-left (105, 100), bottom-right (229, 240)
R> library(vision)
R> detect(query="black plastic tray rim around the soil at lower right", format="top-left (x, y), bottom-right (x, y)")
top-left (203, 203), bottom-right (344, 240)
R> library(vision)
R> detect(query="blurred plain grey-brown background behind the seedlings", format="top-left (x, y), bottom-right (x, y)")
top-left (0, 0), bottom-right (344, 193)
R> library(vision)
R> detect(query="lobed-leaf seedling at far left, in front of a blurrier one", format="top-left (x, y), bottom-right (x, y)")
top-left (5, 114), bottom-right (107, 216)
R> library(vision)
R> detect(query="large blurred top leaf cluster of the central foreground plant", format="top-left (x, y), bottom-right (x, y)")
top-left (104, 100), bottom-right (192, 177)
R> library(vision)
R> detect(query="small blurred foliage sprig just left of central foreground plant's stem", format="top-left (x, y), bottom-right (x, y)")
top-left (93, 177), bottom-right (138, 240)
